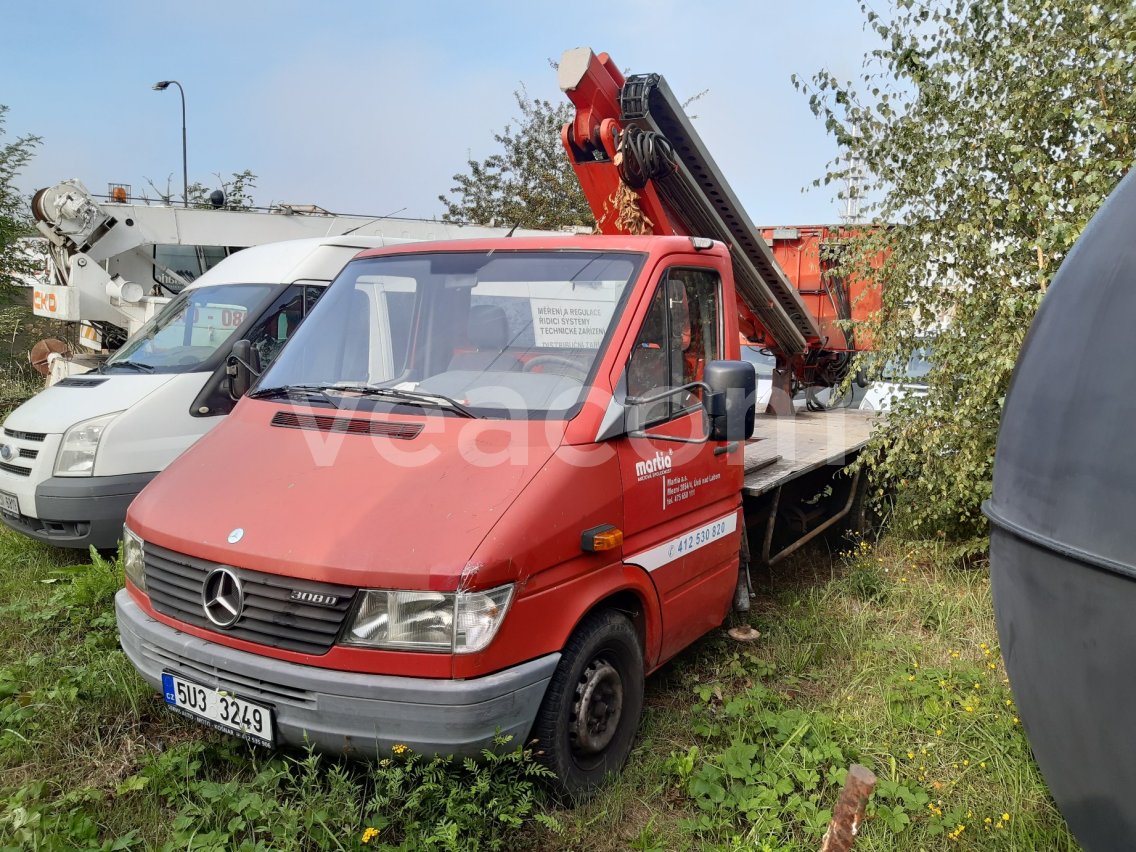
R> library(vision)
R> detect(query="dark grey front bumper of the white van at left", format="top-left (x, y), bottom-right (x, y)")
top-left (0, 471), bottom-right (158, 550)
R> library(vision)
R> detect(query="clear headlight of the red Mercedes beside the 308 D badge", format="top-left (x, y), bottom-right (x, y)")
top-left (343, 584), bottom-right (512, 654)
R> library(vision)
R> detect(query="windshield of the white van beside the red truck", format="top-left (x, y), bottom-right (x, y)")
top-left (103, 284), bottom-right (277, 373)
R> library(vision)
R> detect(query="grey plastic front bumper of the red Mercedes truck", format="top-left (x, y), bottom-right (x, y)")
top-left (115, 588), bottom-right (560, 759)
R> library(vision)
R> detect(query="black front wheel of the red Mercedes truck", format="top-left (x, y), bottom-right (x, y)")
top-left (533, 610), bottom-right (643, 801)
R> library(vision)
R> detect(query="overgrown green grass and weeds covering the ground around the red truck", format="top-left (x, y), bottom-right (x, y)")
top-left (0, 531), bottom-right (1076, 852)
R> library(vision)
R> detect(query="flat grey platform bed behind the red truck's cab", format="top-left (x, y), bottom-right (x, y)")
top-left (742, 408), bottom-right (876, 496)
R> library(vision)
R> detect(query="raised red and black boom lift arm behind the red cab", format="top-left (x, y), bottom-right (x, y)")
top-left (559, 48), bottom-right (853, 384)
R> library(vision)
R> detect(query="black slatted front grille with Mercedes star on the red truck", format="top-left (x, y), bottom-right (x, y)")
top-left (145, 542), bottom-right (356, 654)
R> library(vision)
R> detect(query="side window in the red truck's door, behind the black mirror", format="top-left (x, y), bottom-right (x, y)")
top-left (627, 269), bottom-right (721, 423)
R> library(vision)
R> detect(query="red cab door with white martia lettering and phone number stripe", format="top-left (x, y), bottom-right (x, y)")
top-left (617, 267), bottom-right (743, 659)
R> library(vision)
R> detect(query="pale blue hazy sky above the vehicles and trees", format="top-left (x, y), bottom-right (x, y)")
top-left (0, 0), bottom-right (876, 225)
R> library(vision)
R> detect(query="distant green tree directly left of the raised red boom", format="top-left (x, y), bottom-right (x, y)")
top-left (438, 90), bottom-right (595, 228)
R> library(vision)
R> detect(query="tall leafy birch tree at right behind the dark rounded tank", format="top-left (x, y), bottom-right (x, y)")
top-left (794, 0), bottom-right (1136, 546)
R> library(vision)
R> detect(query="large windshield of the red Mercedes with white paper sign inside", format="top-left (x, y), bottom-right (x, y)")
top-left (254, 250), bottom-right (642, 418)
